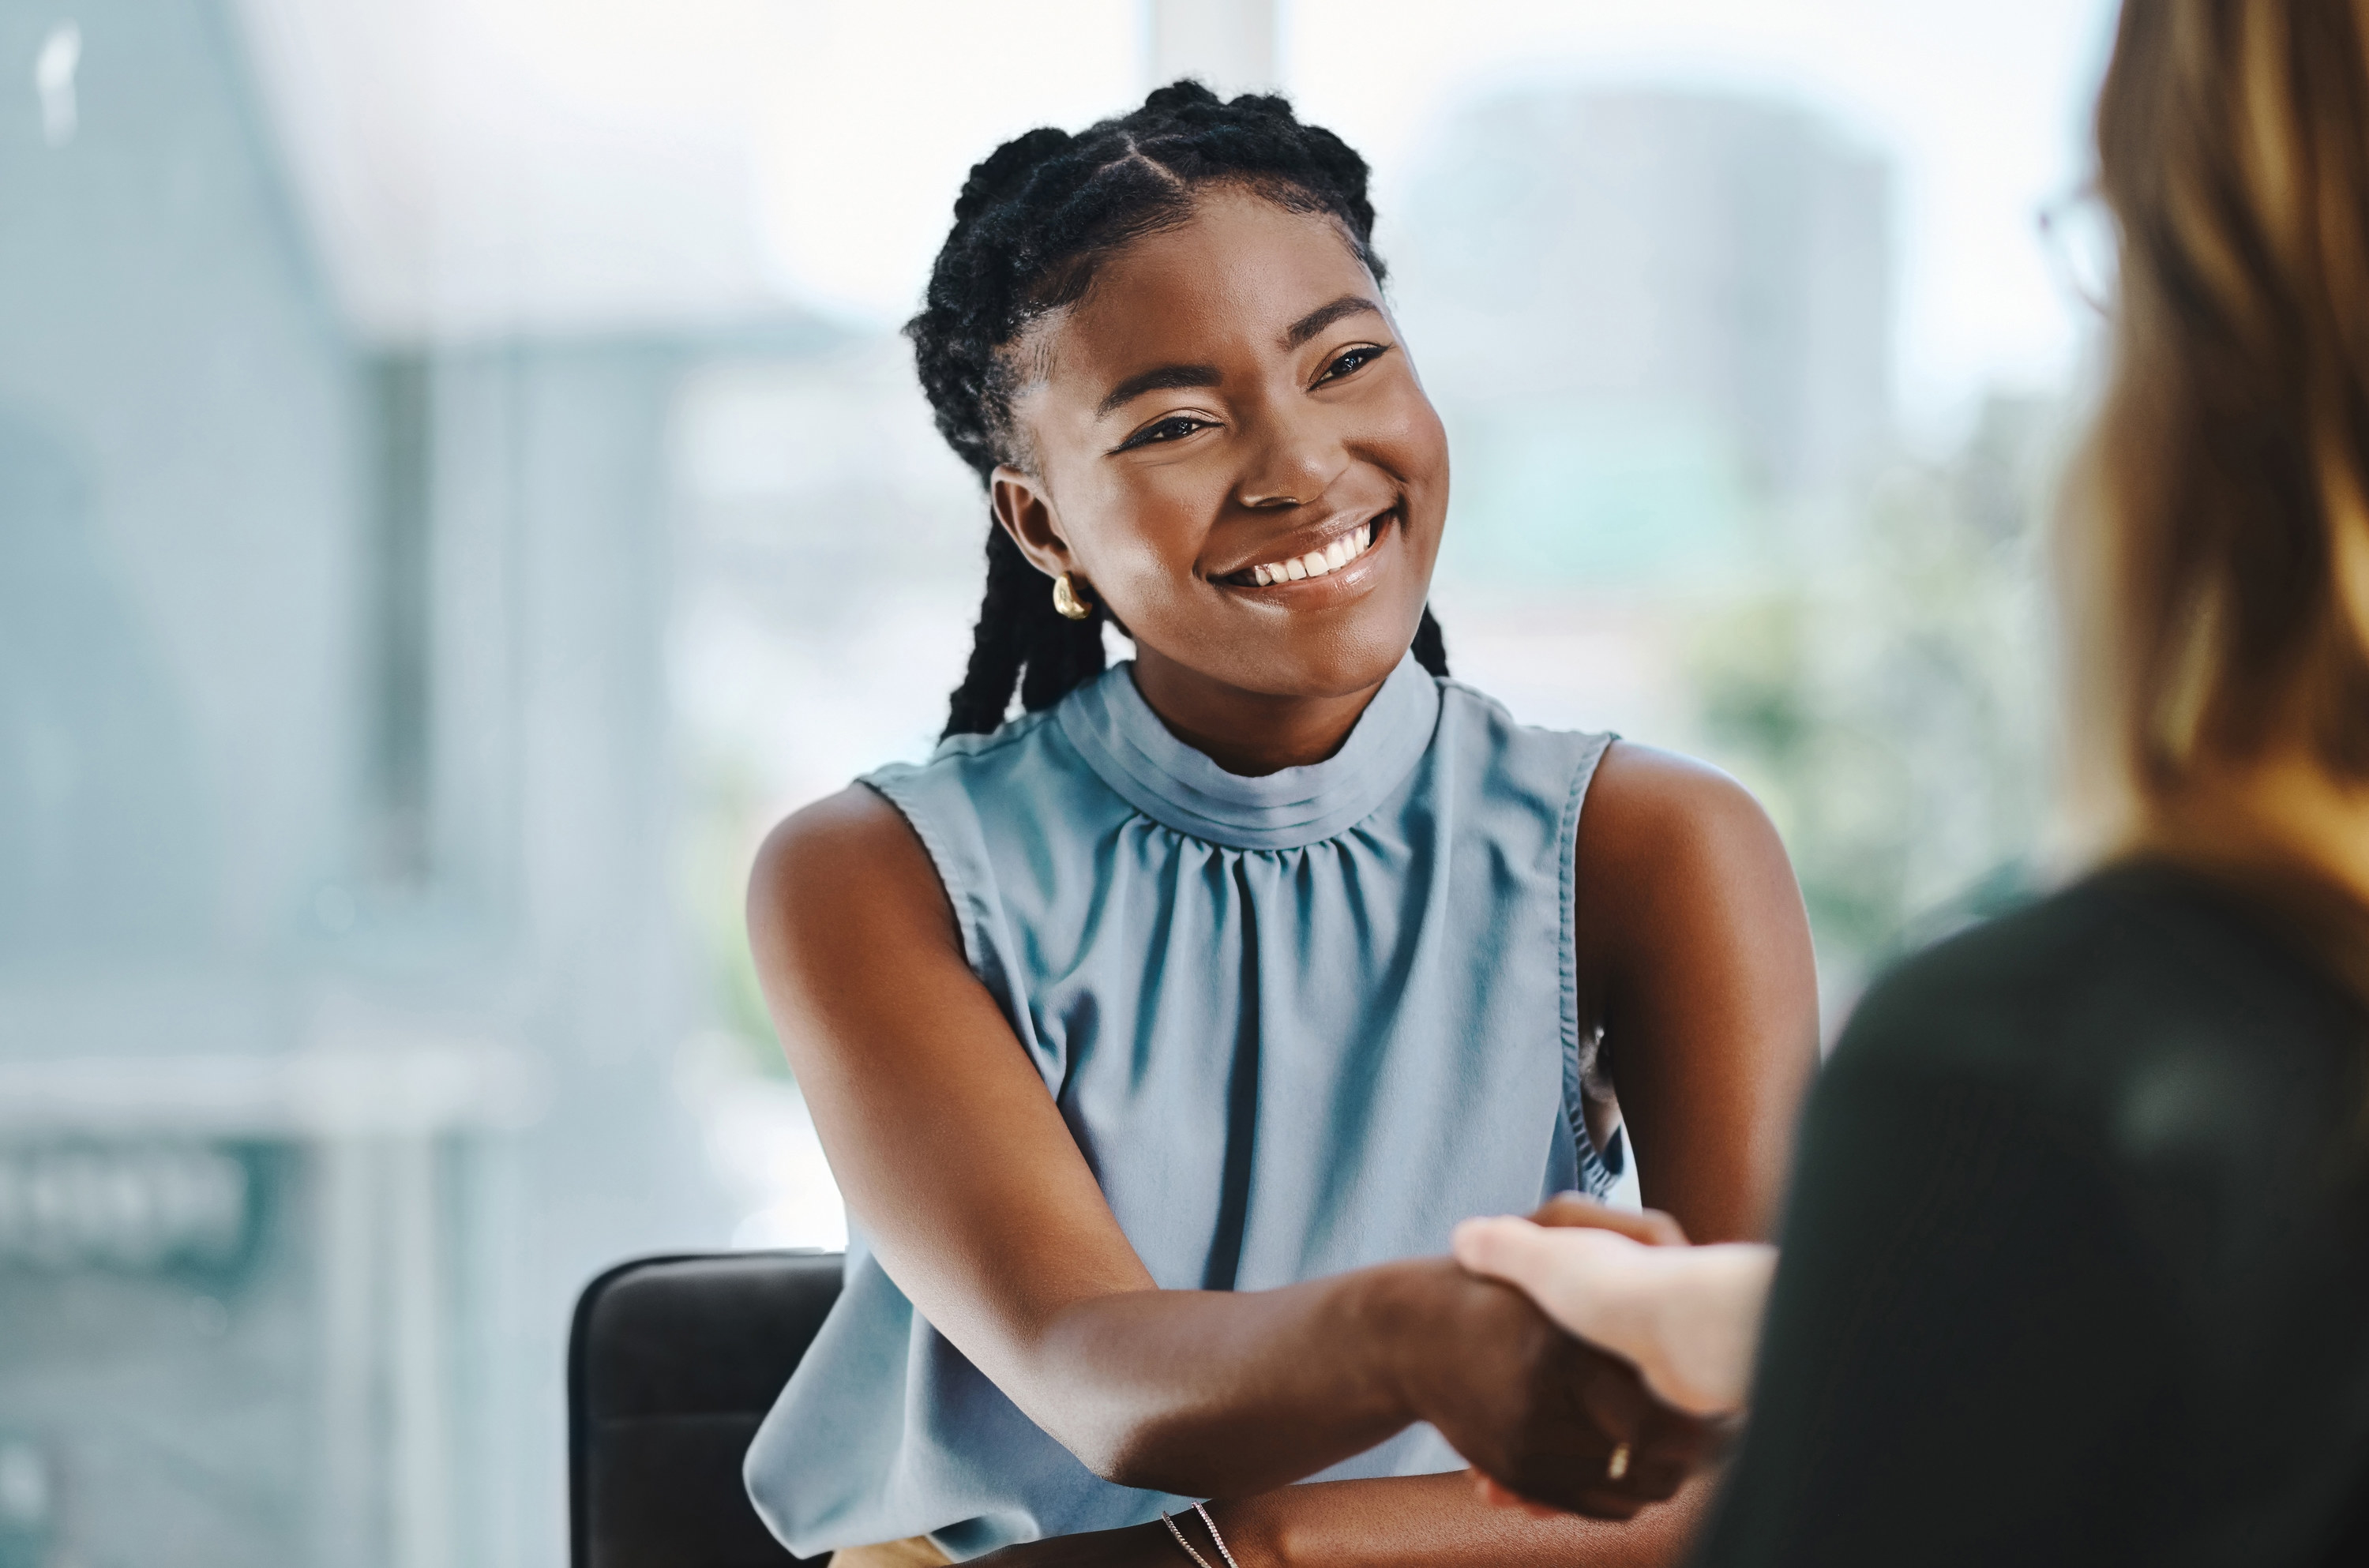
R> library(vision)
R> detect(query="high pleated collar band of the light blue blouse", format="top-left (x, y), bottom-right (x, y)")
top-left (1057, 654), bottom-right (1440, 850)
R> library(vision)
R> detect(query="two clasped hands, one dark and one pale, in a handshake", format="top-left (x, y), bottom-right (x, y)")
top-left (1419, 1196), bottom-right (1777, 1518)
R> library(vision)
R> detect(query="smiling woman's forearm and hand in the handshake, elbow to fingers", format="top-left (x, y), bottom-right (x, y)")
top-left (988, 1258), bottom-right (1708, 1518)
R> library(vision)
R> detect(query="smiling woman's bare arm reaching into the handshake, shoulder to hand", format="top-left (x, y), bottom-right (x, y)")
top-left (749, 789), bottom-right (1699, 1516)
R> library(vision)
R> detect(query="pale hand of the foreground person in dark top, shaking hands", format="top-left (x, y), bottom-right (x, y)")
top-left (1455, 1201), bottom-right (1777, 1416)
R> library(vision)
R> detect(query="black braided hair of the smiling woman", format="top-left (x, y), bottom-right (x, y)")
top-left (905, 81), bottom-right (1447, 734)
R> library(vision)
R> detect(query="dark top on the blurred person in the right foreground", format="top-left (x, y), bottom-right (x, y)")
top-left (1696, 865), bottom-right (2369, 1568)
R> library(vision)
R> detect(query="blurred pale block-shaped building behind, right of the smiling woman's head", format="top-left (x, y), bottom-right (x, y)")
top-left (1398, 88), bottom-right (1893, 587)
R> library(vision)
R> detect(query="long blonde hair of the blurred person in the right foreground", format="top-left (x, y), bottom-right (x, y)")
top-left (2066, 0), bottom-right (2369, 817)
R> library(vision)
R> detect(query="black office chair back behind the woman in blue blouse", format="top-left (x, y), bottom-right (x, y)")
top-left (569, 1253), bottom-right (841, 1568)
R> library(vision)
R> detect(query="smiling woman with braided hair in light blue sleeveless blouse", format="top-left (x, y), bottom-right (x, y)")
top-left (749, 83), bottom-right (1817, 1568)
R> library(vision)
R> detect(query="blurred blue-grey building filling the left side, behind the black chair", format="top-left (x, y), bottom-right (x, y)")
top-left (0, 0), bottom-right (777, 1568)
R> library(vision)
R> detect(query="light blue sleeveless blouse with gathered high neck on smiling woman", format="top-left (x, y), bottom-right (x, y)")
top-left (746, 656), bottom-right (1618, 1559)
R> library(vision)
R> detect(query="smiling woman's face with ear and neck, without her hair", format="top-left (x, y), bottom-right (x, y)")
top-left (988, 185), bottom-right (1447, 775)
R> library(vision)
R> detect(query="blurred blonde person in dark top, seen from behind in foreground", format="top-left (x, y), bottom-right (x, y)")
top-left (1457, 0), bottom-right (2369, 1568)
